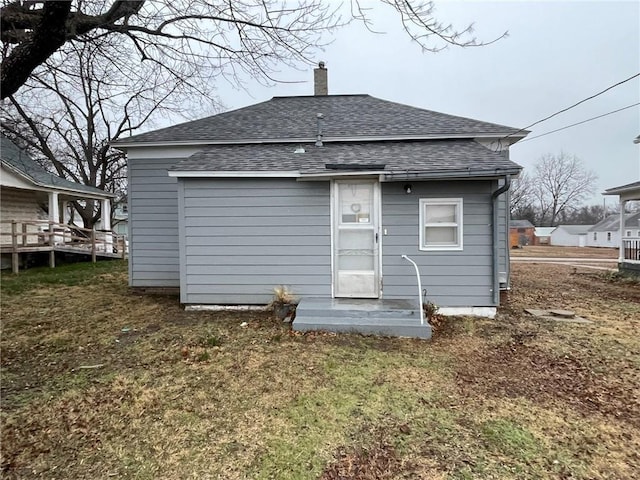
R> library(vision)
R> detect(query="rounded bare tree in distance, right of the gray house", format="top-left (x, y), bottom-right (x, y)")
top-left (533, 152), bottom-right (598, 225)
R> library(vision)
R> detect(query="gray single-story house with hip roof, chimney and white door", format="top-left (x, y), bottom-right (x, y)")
top-left (115, 67), bottom-right (527, 338)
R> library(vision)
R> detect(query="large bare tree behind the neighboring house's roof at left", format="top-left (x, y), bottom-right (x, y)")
top-left (0, 38), bottom-right (188, 228)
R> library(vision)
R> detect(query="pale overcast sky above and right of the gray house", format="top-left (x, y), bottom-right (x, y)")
top-left (215, 0), bottom-right (640, 205)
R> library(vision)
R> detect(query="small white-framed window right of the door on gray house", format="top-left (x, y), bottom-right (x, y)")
top-left (420, 198), bottom-right (462, 250)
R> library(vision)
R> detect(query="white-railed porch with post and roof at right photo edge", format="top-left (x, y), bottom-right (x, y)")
top-left (594, 180), bottom-right (640, 274)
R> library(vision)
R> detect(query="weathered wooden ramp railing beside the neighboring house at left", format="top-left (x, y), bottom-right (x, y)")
top-left (0, 220), bottom-right (127, 273)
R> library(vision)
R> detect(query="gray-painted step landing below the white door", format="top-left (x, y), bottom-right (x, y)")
top-left (293, 298), bottom-right (431, 339)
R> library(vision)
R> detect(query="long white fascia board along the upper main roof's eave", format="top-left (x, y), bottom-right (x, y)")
top-left (111, 132), bottom-right (528, 149)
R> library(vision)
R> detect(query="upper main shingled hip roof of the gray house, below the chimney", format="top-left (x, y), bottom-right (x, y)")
top-left (114, 95), bottom-right (528, 146)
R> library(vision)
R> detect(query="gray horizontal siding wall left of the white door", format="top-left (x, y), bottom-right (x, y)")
top-left (179, 179), bottom-right (331, 304)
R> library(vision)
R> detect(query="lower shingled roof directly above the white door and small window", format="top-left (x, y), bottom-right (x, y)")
top-left (170, 139), bottom-right (521, 176)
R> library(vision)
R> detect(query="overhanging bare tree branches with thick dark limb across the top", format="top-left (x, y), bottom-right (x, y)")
top-left (0, 0), bottom-right (504, 98)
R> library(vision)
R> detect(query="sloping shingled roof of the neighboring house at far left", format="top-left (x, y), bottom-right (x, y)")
top-left (0, 135), bottom-right (115, 198)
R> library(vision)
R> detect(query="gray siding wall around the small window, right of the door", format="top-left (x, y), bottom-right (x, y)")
top-left (382, 181), bottom-right (496, 307)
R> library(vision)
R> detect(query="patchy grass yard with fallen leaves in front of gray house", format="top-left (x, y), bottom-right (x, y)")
top-left (1, 261), bottom-right (640, 480)
